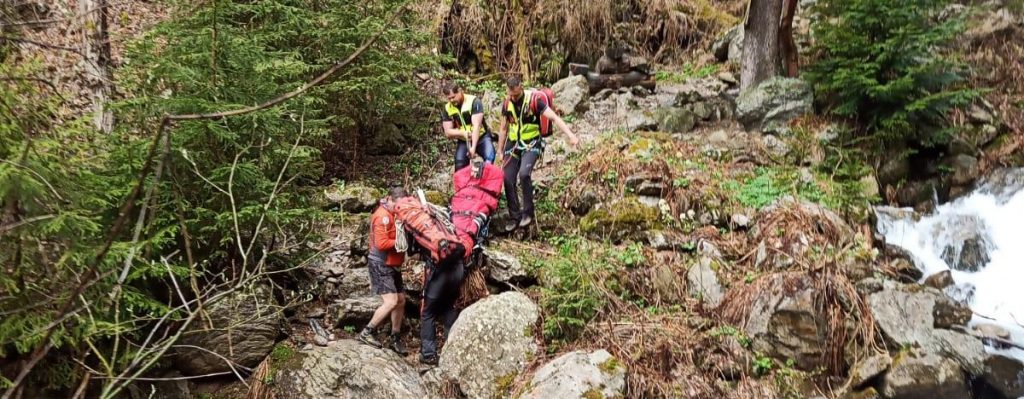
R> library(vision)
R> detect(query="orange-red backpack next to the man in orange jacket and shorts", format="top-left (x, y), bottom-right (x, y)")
top-left (386, 196), bottom-right (466, 266)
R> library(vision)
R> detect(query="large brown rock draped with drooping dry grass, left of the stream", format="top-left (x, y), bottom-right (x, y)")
top-left (742, 274), bottom-right (829, 370)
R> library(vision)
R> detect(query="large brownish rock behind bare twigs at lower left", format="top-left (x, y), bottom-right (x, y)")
top-left (174, 286), bottom-right (285, 375)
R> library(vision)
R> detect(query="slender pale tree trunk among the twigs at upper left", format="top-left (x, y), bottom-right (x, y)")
top-left (78, 0), bottom-right (114, 133)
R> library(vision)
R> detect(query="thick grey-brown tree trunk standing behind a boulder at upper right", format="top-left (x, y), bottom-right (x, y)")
top-left (739, 0), bottom-right (784, 90)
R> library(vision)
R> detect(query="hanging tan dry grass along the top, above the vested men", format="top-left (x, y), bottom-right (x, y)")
top-left (437, 0), bottom-right (744, 80)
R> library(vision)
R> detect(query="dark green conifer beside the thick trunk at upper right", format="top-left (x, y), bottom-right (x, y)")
top-left (806, 0), bottom-right (978, 143)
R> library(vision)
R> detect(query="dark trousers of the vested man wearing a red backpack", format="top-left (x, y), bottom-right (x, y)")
top-left (505, 139), bottom-right (544, 220)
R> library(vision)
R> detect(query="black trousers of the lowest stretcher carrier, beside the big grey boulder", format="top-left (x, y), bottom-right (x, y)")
top-left (420, 258), bottom-right (466, 357)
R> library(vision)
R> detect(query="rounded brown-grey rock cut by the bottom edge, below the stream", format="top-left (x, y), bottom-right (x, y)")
top-left (882, 351), bottom-right (971, 399)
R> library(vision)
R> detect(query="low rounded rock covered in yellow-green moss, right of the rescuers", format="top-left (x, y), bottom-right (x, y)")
top-left (580, 197), bottom-right (658, 241)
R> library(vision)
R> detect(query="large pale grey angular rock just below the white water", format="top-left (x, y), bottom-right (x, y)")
top-left (867, 281), bottom-right (984, 374)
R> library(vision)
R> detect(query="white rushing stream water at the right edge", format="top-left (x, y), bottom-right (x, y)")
top-left (878, 170), bottom-right (1024, 361)
